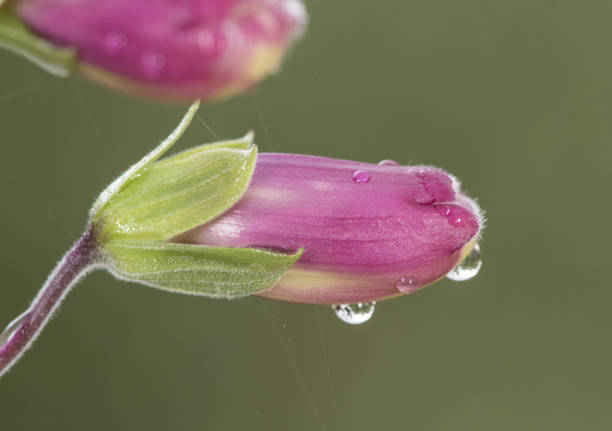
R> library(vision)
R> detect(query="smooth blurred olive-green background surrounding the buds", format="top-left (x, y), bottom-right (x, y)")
top-left (0, 0), bottom-right (612, 431)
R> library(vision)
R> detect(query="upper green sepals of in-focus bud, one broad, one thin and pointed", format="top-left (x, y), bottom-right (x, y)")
top-left (92, 101), bottom-right (257, 244)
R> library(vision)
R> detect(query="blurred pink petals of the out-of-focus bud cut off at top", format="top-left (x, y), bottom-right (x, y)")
top-left (14, 0), bottom-right (307, 100)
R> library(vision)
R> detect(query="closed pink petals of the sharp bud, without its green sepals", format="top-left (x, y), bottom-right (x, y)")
top-left (172, 154), bottom-right (483, 304)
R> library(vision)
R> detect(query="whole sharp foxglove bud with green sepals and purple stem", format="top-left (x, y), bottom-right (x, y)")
top-left (0, 103), bottom-right (483, 376)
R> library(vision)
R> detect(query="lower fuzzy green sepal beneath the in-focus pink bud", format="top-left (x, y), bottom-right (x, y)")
top-left (102, 240), bottom-right (302, 299)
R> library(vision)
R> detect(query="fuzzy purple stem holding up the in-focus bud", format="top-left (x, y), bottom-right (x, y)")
top-left (0, 228), bottom-right (101, 376)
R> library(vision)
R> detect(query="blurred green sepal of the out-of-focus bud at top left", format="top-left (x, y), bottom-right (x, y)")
top-left (0, 9), bottom-right (77, 77)
